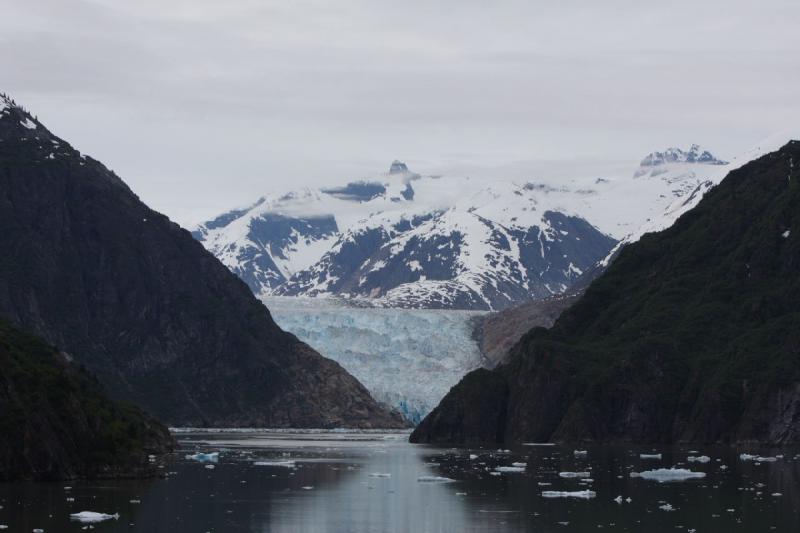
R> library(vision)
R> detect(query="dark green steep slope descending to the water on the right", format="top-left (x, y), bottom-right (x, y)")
top-left (412, 141), bottom-right (800, 444)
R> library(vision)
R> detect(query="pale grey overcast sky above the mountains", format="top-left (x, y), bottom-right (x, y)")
top-left (0, 0), bottom-right (800, 226)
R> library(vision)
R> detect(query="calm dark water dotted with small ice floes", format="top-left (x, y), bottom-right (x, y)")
top-left (0, 433), bottom-right (800, 533)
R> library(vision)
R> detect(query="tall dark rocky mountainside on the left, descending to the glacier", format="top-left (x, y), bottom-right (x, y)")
top-left (0, 98), bottom-right (402, 427)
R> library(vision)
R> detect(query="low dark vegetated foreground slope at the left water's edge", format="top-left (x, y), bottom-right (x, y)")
top-left (0, 320), bottom-right (173, 481)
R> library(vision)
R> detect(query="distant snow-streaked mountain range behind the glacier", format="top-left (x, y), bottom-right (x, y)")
top-left (192, 145), bottom-right (727, 310)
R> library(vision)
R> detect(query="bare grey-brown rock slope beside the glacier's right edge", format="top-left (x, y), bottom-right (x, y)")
top-left (473, 294), bottom-right (578, 368)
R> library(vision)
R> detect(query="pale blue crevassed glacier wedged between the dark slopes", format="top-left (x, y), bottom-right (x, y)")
top-left (262, 296), bottom-right (483, 424)
